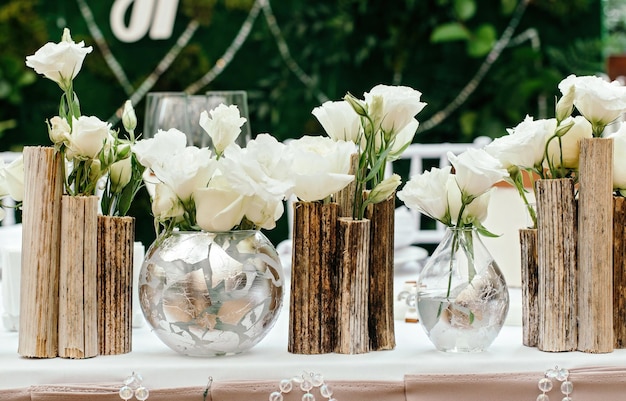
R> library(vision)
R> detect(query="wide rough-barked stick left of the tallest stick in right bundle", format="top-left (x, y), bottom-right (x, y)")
top-left (536, 179), bottom-right (578, 352)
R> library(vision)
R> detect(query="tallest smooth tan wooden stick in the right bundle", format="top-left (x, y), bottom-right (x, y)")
top-left (578, 138), bottom-right (614, 353)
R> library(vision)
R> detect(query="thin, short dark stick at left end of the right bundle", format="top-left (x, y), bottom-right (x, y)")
top-left (519, 228), bottom-right (539, 347)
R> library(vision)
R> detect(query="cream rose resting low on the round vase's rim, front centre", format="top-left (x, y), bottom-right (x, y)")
top-left (193, 180), bottom-right (245, 232)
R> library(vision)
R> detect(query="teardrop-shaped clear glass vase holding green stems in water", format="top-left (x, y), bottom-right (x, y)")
top-left (417, 228), bottom-right (509, 352)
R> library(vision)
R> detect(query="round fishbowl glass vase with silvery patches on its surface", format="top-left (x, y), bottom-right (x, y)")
top-left (138, 230), bottom-right (284, 356)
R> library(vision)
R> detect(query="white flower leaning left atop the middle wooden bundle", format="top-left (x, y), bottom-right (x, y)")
top-left (312, 100), bottom-right (364, 145)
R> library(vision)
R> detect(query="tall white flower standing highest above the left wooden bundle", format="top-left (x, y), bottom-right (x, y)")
top-left (26, 28), bottom-right (93, 91)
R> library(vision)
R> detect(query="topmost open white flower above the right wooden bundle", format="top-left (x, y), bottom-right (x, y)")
top-left (559, 75), bottom-right (626, 137)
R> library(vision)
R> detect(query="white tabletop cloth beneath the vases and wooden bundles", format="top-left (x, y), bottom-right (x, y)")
top-left (0, 262), bottom-right (626, 389)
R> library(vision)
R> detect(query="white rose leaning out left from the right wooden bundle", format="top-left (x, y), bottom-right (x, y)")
top-left (485, 116), bottom-right (556, 169)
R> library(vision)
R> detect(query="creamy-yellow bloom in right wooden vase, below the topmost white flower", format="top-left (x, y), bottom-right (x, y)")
top-left (548, 116), bottom-right (593, 169)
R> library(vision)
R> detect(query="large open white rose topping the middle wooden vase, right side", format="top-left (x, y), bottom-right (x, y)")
top-left (364, 85), bottom-right (426, 135)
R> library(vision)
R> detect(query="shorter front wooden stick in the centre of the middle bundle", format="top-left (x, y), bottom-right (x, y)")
top-left (336, 217), bottom-right (370, 354)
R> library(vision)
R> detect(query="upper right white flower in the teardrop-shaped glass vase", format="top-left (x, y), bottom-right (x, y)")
top-left (448, 148), bottom-right (509, 198)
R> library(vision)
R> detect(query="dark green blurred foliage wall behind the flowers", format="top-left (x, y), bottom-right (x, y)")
top-left (0, 0), bottom-right (604, 243)
